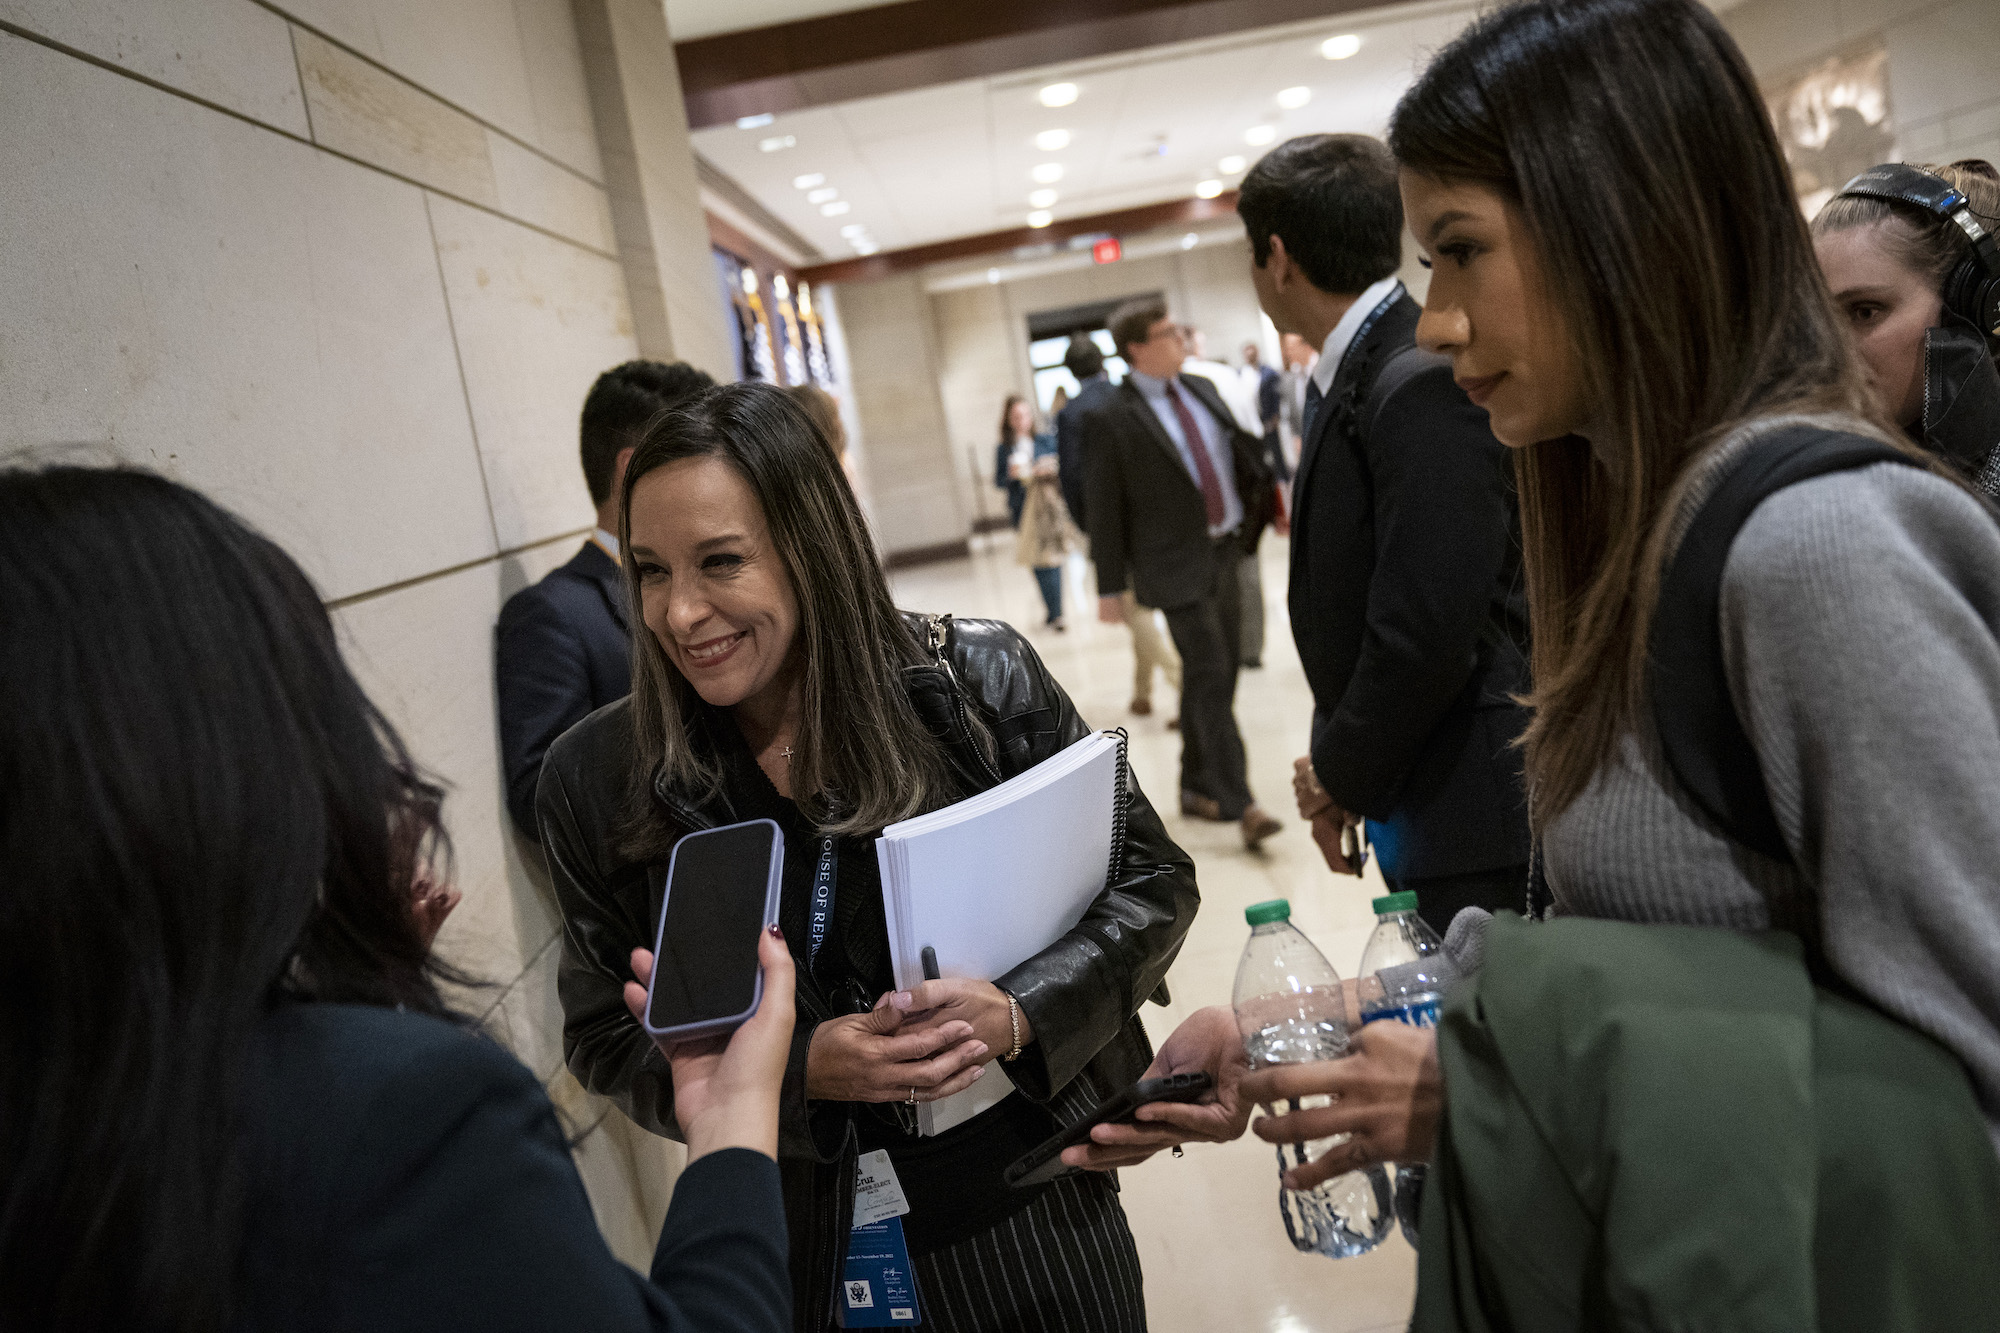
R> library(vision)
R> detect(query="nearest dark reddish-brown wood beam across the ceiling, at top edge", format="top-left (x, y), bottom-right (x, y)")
top-left (674, 0), bottom-right (1378, 130)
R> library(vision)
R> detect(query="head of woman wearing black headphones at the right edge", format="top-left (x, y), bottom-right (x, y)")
top-left (1812, 158), bottom-right (2000, 428)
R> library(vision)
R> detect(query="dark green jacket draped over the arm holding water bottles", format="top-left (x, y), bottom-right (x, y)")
top-left (1410, 915), bottom-right (2000, 1333)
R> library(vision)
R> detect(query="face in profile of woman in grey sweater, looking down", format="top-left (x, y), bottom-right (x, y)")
top-left (1402, 170), bottom-right (1592, 448)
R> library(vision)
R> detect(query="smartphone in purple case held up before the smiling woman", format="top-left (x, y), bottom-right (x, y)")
top-left (644, 819), bottom-right (784, 1039)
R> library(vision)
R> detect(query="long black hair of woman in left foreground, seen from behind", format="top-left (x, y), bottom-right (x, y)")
top-left (0, 468), bottom-right (454, 1329)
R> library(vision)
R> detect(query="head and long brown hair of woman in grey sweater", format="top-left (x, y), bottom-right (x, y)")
top-left (1390, 0), bottom-right (1874, 821)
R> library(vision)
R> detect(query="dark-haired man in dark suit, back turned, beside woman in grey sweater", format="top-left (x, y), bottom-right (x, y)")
top-left (1236, 134), bottom-right (1528, 933)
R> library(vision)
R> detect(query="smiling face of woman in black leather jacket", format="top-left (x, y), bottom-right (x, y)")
top-left (628, 458), bottom-right (798, 709)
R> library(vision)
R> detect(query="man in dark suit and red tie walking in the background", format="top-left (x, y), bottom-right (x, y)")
top-left (1082, 296), bottom-right (1280, 849)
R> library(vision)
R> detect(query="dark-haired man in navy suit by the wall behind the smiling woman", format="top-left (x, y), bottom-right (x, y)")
top-left (494, 360), bottom-right (714, 841)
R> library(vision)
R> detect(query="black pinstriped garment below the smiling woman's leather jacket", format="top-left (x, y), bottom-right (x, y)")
top-left (910, 1171), bottom-right (1146, 1333)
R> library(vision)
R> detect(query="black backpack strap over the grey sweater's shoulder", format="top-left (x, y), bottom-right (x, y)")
top-left (1646, 426), bottom-right (1924, 861)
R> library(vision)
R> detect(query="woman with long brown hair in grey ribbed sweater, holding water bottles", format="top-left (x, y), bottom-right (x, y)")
top-left (1078, 0), bottom-right (2000, 1232)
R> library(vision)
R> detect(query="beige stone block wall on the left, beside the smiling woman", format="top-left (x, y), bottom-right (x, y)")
top-left (0, 0), bottom-right (726, 1267)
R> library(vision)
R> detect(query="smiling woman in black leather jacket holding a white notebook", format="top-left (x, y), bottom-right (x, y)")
top-left (538, 384), bottom-right (1198, 1333)
